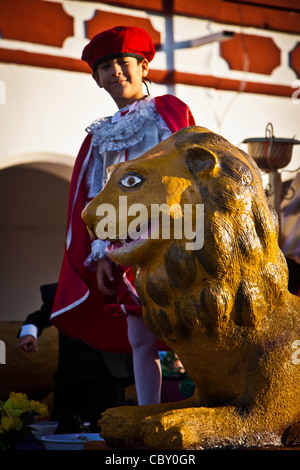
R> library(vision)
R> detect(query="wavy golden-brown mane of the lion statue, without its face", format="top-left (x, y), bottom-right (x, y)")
top-left (141, 130), bottom-right (288, 337)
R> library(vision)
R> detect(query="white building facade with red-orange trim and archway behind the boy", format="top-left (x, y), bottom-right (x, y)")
top-left (0, 0), bottom-right (300, 321)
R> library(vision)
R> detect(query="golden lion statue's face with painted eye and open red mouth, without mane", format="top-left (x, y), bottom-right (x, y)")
top-left (83, 130), bottom-right (211, 266)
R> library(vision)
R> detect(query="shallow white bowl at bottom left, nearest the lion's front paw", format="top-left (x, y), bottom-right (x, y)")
top-left (40, 433), bottom-right (103, 450)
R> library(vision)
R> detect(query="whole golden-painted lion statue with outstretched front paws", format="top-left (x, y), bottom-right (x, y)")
top-left (83, 126), bottom-right (300, 450)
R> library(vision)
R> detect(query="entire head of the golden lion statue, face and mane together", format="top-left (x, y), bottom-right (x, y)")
top-left (83, 127), bottom-right (287, 330)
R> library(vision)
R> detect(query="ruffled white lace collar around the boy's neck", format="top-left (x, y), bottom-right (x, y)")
top-left (86, 97), bottom-right (159, 153)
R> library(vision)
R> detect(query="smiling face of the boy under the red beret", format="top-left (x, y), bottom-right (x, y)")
top-left (93, 57), bottom-right (148, 108)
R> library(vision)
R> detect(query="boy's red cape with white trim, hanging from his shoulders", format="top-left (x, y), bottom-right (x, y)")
top-left (51, 95), bottom-right (195, 352)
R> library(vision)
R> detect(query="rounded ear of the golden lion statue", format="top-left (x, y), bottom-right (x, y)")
top-left (185, 145), bottom-right (218, 177)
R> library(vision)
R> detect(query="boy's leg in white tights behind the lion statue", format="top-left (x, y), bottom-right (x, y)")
top-left (127, 315), bottom-right (161, 405)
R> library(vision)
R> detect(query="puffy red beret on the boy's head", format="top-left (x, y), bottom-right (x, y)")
top-left (81, 26), bottom-right (155, 72)
